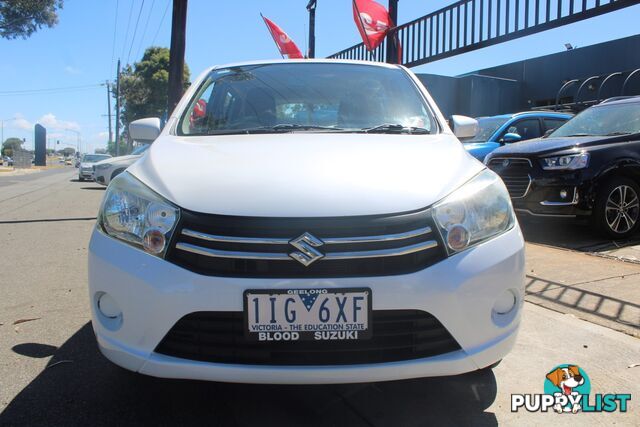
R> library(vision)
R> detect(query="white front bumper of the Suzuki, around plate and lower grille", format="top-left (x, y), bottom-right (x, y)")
top-left (89, 226), bottom-right (524, 384)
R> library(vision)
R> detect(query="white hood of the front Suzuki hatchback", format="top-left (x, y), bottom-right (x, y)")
top-left (128, 133), bottom-right (483, 217)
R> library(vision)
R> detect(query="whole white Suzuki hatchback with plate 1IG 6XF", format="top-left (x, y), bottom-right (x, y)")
top-left (89, 60), bottom-right (524, 384)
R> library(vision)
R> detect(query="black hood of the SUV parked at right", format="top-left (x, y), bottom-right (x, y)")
top-left (491, 136), bottom-right (628, 157)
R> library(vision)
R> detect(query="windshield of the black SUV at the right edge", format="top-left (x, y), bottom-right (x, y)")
top-left (549, 102), bottom-right (640, 137)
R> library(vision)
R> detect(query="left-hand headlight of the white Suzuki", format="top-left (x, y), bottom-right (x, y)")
top-left (98, 172), bottom-right (180, 256)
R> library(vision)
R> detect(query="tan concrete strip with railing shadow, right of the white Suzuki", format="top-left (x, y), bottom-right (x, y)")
top-left (525, 243), bottom-right (640, 337)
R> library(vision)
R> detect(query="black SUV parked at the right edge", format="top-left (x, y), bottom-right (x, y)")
top-left (486, 97), bottom-right (640, 239)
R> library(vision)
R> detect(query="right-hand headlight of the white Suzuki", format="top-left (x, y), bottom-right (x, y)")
top-left (433, 169), bottom-right (515, 255)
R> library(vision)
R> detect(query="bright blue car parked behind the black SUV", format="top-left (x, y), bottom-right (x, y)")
top-left (461, 111), bottom-right (573, 161)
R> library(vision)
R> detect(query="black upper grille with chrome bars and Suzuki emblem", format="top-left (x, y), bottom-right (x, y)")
top-left (166, 210), bottom-right (446, 278)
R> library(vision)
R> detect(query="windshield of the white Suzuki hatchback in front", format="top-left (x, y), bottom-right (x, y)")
top-left (178, 63), bottom-right (437, 135)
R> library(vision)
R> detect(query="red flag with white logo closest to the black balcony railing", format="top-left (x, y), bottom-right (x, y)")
top-left (353, 0), bottom-right (393, 50)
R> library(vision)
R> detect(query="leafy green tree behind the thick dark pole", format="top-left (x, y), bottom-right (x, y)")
top-left (120, 47), bottom-right (190, 127)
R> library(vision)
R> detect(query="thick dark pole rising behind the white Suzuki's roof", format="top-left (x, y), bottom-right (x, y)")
top-left (167, 0), bottom-right (187, 116)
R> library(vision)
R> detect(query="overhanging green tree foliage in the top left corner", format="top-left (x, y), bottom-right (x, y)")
top-left (0, 0), bottom-right (63, 39)
